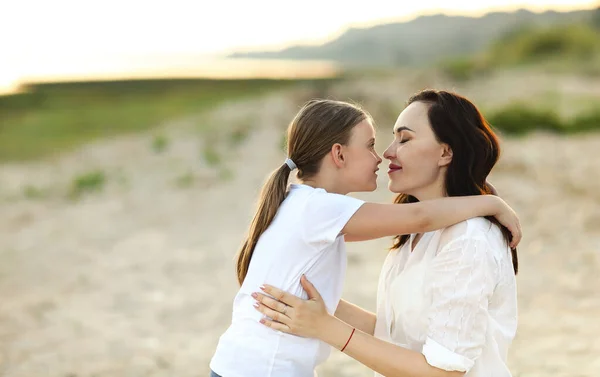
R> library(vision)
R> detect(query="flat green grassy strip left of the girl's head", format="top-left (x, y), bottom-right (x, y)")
top-left (0, 79), bottom-right (311, 162)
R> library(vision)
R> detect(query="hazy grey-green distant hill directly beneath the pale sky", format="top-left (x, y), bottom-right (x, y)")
top-left (230, 10), bottom-right (600, 66)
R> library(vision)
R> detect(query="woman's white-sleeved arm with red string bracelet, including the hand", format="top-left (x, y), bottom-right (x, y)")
top-left (254, 238), bottom-right (496, 377)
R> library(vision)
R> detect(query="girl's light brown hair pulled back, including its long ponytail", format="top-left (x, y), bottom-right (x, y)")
top-left (236, 99), bottom-right (371, 285)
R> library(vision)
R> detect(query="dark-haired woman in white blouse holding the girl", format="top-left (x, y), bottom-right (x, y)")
top-left (254, 90), bottom-right (518, 377)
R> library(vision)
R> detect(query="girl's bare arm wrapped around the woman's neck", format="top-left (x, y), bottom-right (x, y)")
top-left (342, 195), bottom-right (521, 248)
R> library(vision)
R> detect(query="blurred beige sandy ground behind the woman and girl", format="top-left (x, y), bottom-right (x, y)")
top-left (0, 72), bottom-right (600, 377)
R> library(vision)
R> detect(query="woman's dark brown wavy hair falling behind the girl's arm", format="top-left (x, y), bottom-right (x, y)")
top-left (391, 90), bottom-right (519, 274)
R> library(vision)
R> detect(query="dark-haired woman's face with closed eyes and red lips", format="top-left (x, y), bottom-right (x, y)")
top-left (383, 102), bottom-right (452, 200)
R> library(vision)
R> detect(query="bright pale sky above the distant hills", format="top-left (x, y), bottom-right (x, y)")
top-left (0, 0), bottom-right (600, 90)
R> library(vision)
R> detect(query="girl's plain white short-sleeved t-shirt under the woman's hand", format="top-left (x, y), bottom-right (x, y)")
top-left (210, 184), bottom-right (364, 377)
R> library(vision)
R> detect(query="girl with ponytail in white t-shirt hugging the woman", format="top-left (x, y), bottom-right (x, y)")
top-left (210, 100), bottom-right (520, 377)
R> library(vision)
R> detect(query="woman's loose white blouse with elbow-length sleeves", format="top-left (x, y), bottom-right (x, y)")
top-left (375, 218), bottom-right (517, 377)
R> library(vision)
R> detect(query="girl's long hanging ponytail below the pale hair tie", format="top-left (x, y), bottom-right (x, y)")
top-left (236, 163), bottom-right (291, 285)
